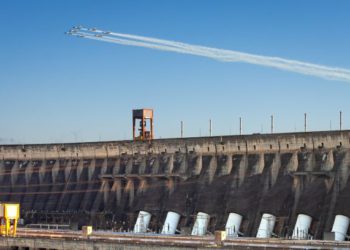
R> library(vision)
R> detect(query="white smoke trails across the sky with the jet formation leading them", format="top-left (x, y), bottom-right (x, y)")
top-left (69, 28), bottom-right (350, 82)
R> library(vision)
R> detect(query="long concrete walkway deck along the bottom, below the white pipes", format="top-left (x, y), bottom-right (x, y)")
top-left (0, 229), bottom-right (350, 250)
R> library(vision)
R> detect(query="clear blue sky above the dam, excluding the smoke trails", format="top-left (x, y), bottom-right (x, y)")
top-left (0, 0), bottom-right (350, 144)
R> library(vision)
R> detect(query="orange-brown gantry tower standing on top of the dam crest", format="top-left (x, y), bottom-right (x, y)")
top-left (132, 109), bottom-right (154, 141)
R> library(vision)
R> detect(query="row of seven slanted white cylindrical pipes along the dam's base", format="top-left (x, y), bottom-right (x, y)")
top-left (134, 211), bottom-right (350, 241)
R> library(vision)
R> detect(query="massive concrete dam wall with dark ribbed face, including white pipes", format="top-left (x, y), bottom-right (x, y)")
top-left (0, 130), bottom-right (350, 240)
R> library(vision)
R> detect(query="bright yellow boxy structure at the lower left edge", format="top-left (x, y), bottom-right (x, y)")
top-left (0, 203), bottom-right (19, 236)
